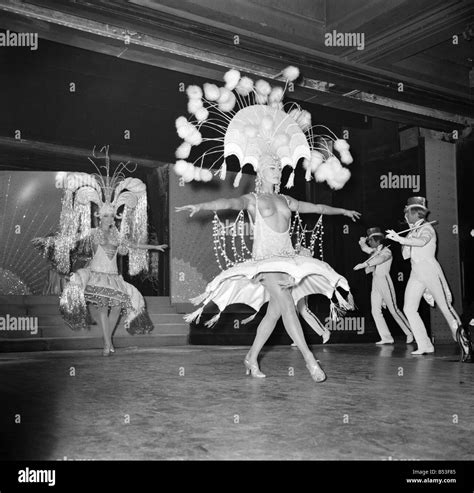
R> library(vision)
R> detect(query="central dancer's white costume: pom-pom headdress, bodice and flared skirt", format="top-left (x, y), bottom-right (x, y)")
top-left (174, 66), bottom-right (353, 326)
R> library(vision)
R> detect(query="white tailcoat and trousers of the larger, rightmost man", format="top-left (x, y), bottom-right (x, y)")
top-left (402, 219), bottom-right (461, 353)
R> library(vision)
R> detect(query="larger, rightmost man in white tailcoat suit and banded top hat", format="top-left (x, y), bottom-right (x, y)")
top-left (387, 197), bottom-right (472, 362)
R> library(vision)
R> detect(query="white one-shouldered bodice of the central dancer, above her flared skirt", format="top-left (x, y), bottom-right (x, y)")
top-left (252, 195), bottom-right (295, 260)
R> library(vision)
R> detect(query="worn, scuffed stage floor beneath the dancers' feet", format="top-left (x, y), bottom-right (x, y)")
top-left (0, 343), bottom-right (474, 460)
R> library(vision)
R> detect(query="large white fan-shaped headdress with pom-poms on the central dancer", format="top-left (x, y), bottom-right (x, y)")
top-left (174, 66), bottom-right (352, 190)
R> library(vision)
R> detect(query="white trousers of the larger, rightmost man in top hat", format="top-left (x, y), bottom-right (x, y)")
top-left (403, 259), bottom-right (461, 349)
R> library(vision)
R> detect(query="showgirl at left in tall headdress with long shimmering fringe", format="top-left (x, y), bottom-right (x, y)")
top-left (39, 147), bottom-right (166, 356)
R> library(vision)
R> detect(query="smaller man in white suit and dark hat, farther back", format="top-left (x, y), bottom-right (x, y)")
top-left (354, 227), bottom-right (413, 345)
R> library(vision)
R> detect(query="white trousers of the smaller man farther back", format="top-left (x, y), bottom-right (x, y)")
top-left (370, 275), bottom-right (411, 341)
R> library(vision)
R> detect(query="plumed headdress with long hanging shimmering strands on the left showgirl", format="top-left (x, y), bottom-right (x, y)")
top-left (55, 146), bottom-right (148, 275)
